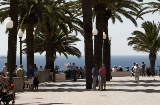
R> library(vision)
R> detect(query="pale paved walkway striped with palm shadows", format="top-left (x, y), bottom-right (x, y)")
top-left (15, 76), bottom-right (160, 105)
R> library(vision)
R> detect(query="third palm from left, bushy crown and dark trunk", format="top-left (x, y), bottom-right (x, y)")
top-left (31, 0), bottom-right (82, 69)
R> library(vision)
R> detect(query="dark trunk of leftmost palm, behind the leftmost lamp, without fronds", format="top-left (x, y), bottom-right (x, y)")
top-left (8, 0), bottom-right (18, 79)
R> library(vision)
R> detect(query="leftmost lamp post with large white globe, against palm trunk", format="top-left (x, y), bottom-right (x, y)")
top-left (6, 17), bottom-right (13, 81)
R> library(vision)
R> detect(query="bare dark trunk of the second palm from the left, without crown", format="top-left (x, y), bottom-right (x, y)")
top-left (26, 24), bottom-right (34, 73)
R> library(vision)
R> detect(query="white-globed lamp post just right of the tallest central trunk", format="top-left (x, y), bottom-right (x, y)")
top-left (92, 27), bottom-right (98, 64)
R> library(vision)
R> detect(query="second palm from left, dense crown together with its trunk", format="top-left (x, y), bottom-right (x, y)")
top-left (19, 0), bottom-right (54, 72)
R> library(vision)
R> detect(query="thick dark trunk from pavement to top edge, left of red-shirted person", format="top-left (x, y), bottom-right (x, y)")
top-left (82, 0), bottom-right (93, 89)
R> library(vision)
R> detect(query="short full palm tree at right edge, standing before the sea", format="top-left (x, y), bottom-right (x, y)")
top-left (127, 21), bottom-right (160, 75)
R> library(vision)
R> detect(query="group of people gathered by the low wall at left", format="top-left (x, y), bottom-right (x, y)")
top-left (1, 63), bottom-right (44, 91)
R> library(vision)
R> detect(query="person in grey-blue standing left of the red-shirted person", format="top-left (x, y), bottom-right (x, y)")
top-left (92, 64), bottom-right (98, 90)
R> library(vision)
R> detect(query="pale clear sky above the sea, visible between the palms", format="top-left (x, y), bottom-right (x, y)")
top-left (0, 0), bottom-right (160, 56)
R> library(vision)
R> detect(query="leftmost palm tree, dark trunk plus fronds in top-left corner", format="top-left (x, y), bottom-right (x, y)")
top-left (0, 0), bottom-right (18, 79)
